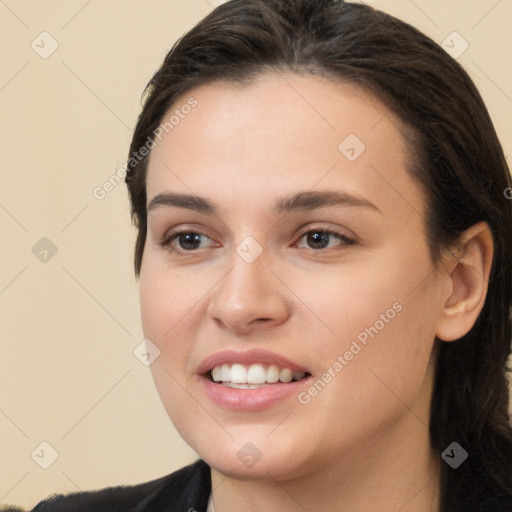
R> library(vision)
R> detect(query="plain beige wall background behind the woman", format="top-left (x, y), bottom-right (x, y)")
top-left (0, 0), bottom-right (512, 507)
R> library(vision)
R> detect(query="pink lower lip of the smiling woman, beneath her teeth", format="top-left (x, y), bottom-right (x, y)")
top-left (201, 377), bottom-right (310, 411)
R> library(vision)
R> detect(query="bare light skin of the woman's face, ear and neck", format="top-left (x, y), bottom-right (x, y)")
top-left (140, 73), bottom-right (492, 512)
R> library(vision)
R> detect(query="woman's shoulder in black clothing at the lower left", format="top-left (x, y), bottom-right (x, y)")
top-left (32, 460), bottom-right (211, 512)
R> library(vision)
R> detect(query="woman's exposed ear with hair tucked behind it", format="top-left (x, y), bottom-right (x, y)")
top-left (436, 222), bottom-right (494, 341)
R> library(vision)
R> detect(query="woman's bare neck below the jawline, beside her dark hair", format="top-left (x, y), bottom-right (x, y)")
top-left (208, 414), bottom-right (440, 512)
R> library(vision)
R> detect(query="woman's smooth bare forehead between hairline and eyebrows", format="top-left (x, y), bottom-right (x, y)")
top-left (147, 73), bottom-right (424, 222)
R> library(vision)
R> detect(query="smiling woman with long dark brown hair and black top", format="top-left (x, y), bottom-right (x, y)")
top-left (29, 0), bottom-right (512, 512)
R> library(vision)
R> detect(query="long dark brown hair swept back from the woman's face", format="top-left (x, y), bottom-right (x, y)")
top-left (126, 0), bottom-right (512, 512)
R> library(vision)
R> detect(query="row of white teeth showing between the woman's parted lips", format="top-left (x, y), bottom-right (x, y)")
top-left (206, 363), bottom-right (310, 389)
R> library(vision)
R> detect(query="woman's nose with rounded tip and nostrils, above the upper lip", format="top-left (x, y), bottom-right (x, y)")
top-left (207, 245), bottom-right (290, 334)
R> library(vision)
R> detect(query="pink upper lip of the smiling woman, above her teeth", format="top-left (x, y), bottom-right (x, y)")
top-left (197, 349), bottom-right (307, 375)
